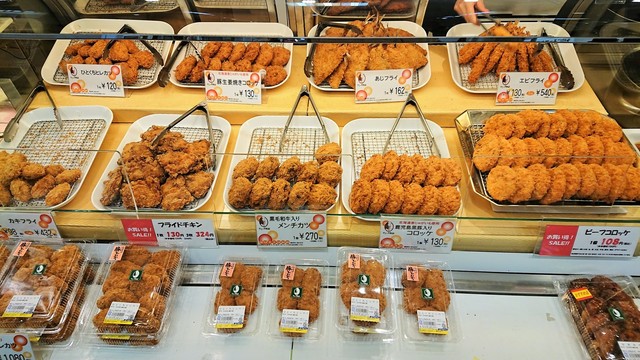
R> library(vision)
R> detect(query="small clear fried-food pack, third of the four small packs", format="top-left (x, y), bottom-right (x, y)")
top-left (337, 247), bottom-right (395, 335)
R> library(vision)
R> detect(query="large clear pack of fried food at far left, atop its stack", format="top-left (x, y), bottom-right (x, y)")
top-left (0, 241), bottom-right (89, 337)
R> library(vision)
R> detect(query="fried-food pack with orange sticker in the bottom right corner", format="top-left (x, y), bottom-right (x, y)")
top-left (554, 275), bottom-right (640, 360)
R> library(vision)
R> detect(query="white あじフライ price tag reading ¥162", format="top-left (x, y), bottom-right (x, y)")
top-left (355, 69), bottom-right (413, 104)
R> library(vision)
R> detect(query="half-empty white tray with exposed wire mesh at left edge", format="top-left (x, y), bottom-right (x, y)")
top-left (0, 106), bottom-right (113, 209)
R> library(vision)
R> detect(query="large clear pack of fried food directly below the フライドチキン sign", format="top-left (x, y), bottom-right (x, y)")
top-left (86, 245), bottom-right (185, 346)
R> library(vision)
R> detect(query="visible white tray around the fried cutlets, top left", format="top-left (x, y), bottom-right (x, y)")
top-left (41, 19), bottom-right (173, 89)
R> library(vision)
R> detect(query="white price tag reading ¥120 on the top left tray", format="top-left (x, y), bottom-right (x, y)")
top-left (67, 64), bottom-right (124, 97)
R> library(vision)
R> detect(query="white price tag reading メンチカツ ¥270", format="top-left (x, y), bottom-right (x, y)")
top-left (255, 213), bottom-right (327, 248)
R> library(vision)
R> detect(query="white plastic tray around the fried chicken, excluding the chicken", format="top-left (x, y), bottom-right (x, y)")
top-left (91, 114), bottom-right (231, 211)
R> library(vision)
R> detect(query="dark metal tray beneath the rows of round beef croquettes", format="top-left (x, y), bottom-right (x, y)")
top-left (456, 110), bottom-right (640, 214)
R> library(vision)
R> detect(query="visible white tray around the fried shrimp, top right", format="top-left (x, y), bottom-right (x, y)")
top-left (447, 22), bottom-right (584, 94)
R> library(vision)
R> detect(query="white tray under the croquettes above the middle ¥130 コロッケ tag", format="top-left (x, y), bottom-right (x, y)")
top-left (342, 118), bottom-right (451, 221)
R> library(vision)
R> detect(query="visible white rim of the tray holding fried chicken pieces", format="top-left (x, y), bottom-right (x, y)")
top-left (91, 114), bottom-right (231, 211)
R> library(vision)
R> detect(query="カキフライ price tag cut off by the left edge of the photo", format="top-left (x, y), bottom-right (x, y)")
top-left (0, 212), bottom-right (61, 241)
